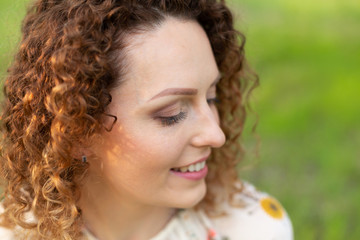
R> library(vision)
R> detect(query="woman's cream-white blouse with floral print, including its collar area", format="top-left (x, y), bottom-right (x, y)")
top-left (0, 183), bottom-right (294, 240)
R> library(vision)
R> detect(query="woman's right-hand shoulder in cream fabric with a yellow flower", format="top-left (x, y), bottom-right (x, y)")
top-left (211, 182), bottom-right (293, 240)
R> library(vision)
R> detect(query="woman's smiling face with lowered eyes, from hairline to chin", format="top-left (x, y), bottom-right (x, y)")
top-left (92, 18), bottom-right (225, 208)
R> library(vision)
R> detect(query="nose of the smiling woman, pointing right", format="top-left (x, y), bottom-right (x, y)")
top-left (191, 105), bottom-right (225, 148)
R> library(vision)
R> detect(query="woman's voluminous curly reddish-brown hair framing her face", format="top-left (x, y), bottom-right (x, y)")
top-left (0, 0), bottom-right (258, 239)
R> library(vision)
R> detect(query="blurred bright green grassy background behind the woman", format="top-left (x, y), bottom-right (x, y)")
top-left (0, 0), bottom-right (360, 240)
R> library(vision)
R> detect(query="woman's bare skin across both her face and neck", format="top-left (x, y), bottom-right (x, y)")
top-left (80, 18), bottom-right (225, 240)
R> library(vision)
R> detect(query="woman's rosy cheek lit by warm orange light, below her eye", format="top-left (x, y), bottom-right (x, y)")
top-left (102, 125), bottom-right (185, 176)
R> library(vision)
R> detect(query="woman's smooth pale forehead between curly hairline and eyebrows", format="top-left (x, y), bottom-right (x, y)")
top-left (112, 18), bottom-right (218, 105)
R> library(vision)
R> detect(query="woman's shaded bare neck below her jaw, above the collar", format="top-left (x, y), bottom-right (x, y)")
top-left (79, 174), bottom-right (175, 240)
